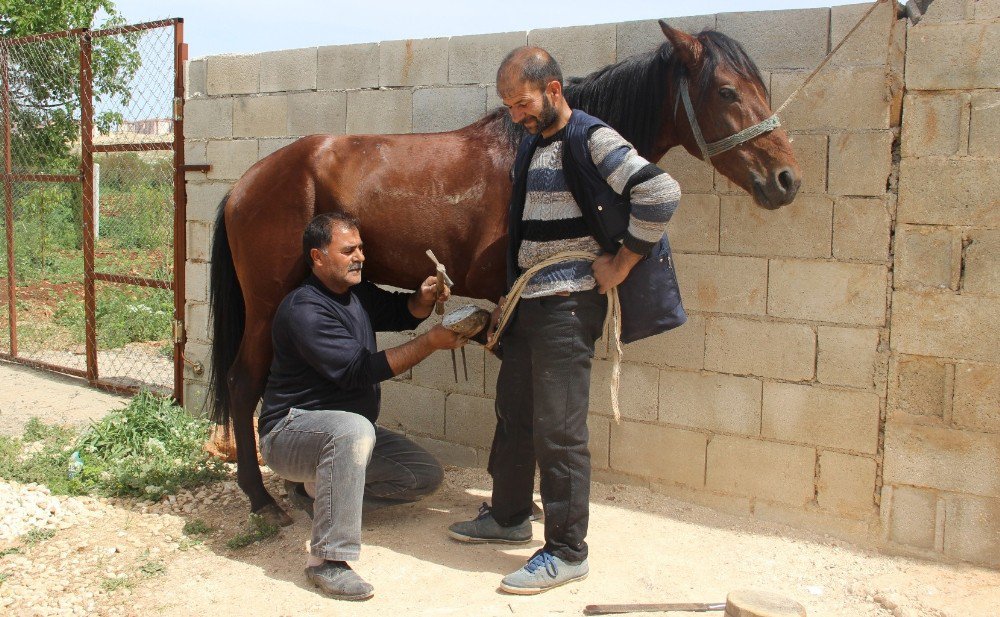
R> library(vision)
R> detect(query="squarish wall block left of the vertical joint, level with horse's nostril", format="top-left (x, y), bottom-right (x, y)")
top-left (829, 131), bottom-right (892, 196)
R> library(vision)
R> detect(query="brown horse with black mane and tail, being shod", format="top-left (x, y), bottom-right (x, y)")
top-left (211, 21), bottom-right (799, 524)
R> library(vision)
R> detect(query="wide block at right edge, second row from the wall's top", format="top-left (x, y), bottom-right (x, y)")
top-left (906, 22), bottom-right (1000, 90)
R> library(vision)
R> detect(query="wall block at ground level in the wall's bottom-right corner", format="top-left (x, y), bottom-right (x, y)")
top-left (944, 495), bottom-right (1000, 567)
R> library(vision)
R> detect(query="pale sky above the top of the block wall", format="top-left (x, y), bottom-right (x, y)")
top-left (105, 0), bottom-right (858, 59)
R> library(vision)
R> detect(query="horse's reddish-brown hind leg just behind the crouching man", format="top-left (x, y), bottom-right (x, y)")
top-left (228, 313), bottom-right (292, 526)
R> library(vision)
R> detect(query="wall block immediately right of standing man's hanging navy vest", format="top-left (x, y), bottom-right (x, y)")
top-left (674, 254), bottom-right (767, 315)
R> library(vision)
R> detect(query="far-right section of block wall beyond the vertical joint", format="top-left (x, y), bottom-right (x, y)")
top-left (882, 0), bottom-right (1000, 567)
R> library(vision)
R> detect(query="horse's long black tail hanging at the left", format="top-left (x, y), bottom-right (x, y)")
top-left (208, 195), bottom-right (246, 431)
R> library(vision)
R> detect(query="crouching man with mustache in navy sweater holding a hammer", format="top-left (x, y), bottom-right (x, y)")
top-left (258, 212), bottom-right (465, 600)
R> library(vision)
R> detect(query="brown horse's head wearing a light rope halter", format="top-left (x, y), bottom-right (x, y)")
top-left (660, 20), bottom-right (801, 209)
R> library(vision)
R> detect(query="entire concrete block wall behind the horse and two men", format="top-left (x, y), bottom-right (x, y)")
top-left (185, 0), bottom-right (1000, 561)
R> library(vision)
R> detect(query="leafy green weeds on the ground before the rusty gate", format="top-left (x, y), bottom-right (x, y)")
top-left (0, 392), bottom-right (225, 499)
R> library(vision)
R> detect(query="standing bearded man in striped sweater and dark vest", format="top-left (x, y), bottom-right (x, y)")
top-left (449, 47), bottom-right (680, 594)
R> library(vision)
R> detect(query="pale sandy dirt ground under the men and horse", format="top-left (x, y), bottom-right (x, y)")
top-left (0, 363), bottom-right (1000, 617)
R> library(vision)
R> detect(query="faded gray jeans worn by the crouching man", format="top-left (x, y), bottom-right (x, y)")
top-left (260, 408), bottom-right (444, 561)
